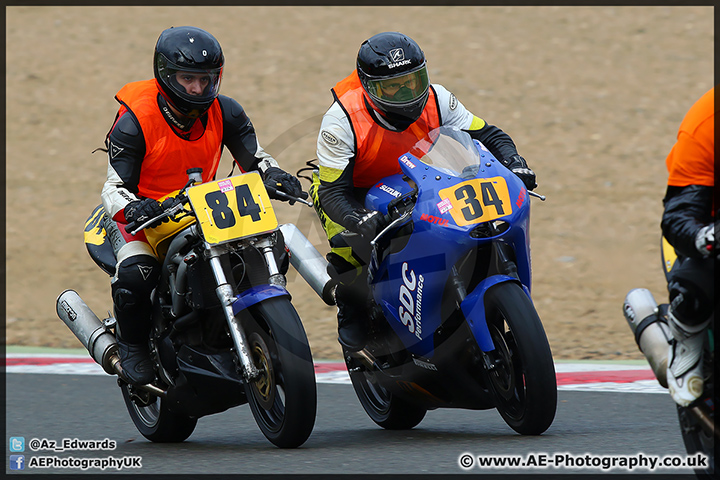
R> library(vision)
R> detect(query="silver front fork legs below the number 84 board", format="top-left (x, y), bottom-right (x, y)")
top-left (206, 237), bottom-right (285, 381)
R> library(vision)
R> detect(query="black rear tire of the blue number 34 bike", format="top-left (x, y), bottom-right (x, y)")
top-left (343, 349), bottom-right (427, 430)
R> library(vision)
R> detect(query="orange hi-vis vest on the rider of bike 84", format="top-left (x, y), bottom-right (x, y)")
top-left (115, 79), bottom-right (223, 200)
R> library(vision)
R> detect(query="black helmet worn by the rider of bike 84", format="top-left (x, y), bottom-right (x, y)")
top-left (153, 27), bottom-right (225, 118)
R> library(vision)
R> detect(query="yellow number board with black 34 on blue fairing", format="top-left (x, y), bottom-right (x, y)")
top-left (438, 177), bottom-right (512, 227)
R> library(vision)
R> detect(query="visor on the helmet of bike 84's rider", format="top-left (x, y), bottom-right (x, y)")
top-left (158, 55), bottom-right (222, 104)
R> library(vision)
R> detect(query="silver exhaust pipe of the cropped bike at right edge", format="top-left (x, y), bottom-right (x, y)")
top-left (623, 288), bottom-right (672, 388)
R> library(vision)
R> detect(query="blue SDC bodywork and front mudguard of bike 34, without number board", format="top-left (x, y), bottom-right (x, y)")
top-left (365, 137), bottom-right (531, 358)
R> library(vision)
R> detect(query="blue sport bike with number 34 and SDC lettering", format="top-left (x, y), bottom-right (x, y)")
top-left (344, 127), bottom-right (557, 435)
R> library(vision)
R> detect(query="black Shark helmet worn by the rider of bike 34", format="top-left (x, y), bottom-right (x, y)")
top-left (357, 32), bottom-right (430, 123)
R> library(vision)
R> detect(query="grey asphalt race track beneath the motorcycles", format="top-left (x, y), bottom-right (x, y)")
top-left (1, 358), bottom-right (692, 475)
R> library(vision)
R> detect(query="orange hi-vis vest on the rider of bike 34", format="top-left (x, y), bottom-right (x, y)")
top-left (332, 70), bottom-right (440, 188)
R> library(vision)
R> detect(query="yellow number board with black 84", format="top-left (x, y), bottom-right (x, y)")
top-left (187, 172), bottom-right (278, 244)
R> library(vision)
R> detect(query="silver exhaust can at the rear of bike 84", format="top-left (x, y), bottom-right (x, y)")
top-left (56, 290), bottom-right (118, 375)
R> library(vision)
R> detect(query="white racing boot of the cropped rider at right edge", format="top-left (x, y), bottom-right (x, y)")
top-left (667, 310), bottom-right (710, 407)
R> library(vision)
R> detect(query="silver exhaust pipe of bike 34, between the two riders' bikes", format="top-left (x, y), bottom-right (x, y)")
top-left (280, 223), bottom-right (336, 305)
